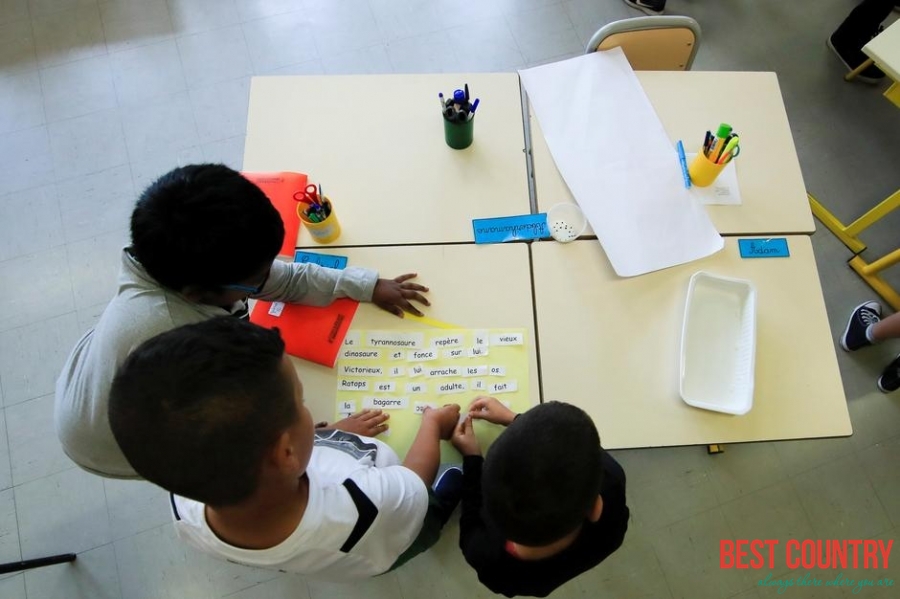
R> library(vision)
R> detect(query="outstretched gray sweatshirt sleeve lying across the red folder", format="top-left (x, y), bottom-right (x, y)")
top-left (255, 260), bottom-right (378, 306)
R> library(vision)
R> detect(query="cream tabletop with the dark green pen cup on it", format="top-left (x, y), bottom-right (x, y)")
top-left (243, 73), bottom-right (531, 247)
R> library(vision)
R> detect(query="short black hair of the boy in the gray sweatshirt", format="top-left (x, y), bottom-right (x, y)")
top-left (131, 164), bottom-right (284, 291)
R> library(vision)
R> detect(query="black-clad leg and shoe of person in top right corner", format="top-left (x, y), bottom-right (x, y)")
top-left (826, 0), bottom-right (895, 83)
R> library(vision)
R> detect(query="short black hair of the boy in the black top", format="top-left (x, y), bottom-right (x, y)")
top-left (482, 401), bottom-right (603, 547)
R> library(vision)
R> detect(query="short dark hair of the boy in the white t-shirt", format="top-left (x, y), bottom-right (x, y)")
top-left (109, 316), bottom-right (299, 507)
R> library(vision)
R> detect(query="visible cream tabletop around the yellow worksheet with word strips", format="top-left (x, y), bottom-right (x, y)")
top-left (293, 243), bottom-right (540, 421)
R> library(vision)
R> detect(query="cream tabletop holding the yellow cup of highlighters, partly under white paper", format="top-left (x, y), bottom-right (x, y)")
top-left (529, 71), bottom-right (815, 235)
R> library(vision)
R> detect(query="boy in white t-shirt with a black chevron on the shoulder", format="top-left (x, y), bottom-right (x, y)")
top-left (109, 317), bottom-right (462, 581)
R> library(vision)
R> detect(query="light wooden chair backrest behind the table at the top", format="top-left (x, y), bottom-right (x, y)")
top-left (584, 16), bottom-right (700, 71)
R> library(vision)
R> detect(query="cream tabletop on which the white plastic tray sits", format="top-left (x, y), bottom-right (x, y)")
top-left (531, 236), bottom-right (852, 449)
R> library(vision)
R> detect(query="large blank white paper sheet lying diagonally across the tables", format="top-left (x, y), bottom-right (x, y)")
top-left (519, 48), bottom-right (724, 277)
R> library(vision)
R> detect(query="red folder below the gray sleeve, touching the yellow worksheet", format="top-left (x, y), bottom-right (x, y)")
top-left (250, 298), bottom-right (359, 368)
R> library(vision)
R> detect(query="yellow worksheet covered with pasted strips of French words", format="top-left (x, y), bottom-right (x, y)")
top-left (335, 329), bottom-right (531, 463)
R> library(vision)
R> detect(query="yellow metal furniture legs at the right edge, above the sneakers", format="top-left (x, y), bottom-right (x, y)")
top-left (806, 190), bottom-right (900, 311)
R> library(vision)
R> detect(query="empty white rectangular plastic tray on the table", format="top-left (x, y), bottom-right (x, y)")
top-left (680, 271), bottom-right (756, 414)
